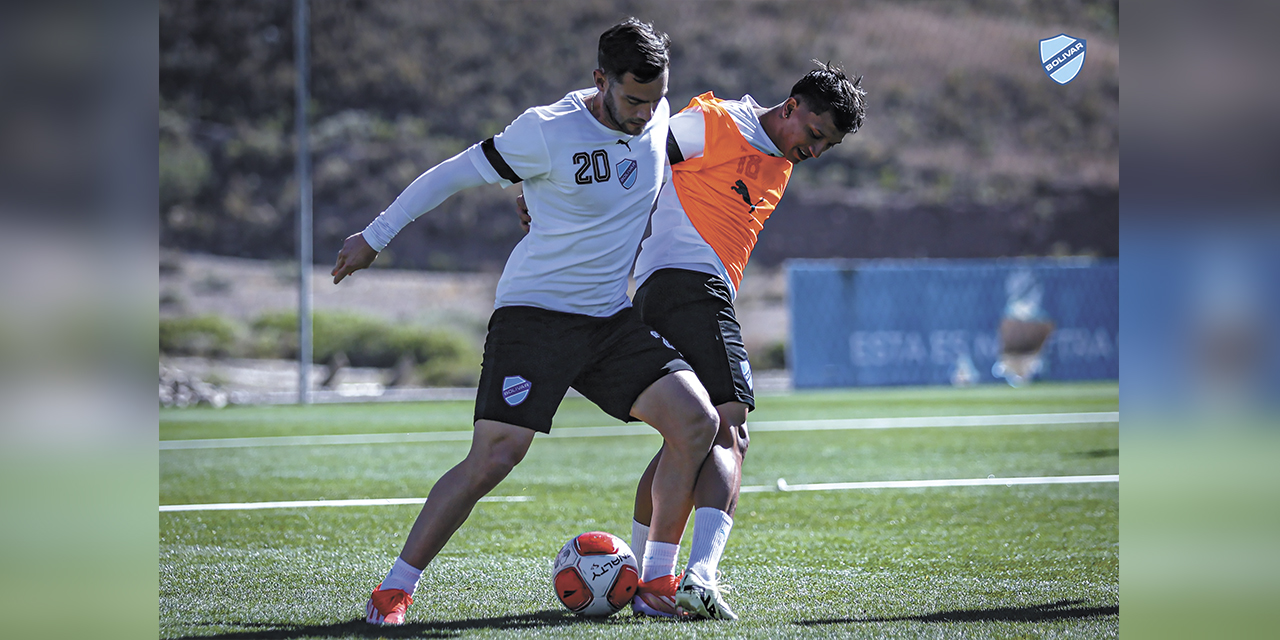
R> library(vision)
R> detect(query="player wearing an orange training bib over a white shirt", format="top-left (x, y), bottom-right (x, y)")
top-left (517, 64), bottom-right (865, 620)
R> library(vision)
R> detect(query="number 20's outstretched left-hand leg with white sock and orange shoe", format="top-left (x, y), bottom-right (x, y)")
top-left (365, 420), bottom-right (534, 625)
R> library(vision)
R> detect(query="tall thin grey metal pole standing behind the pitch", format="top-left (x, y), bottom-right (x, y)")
top-left (293, 0), bottom-right (311, 404)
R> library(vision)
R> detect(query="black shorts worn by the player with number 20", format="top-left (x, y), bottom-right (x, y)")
top-left (475, 307), bottom-right (692, 433)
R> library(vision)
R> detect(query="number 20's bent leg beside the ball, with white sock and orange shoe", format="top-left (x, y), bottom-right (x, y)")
top-left (631, 371), bottom-right (718, 616)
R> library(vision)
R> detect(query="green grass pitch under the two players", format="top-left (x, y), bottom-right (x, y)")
top-left (159, 384), bottom-right (1120, 639)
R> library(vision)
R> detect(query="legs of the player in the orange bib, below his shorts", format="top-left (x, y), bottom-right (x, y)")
top-left (632, 402), bottom-right (749, 620)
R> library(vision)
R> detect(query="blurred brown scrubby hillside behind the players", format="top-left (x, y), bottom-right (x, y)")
top-left (159, 0), bottom-right (1120, 270)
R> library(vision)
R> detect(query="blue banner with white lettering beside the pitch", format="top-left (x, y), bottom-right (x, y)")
top-left (787, 259), bottom-right (1120, 388)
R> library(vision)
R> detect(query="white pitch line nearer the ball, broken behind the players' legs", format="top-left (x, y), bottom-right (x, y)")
top-left (160, 475), bottom-right (1120, 513)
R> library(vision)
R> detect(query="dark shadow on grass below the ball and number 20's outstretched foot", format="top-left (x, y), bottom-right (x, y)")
top-left (167, 609), bottom-right (596, 640)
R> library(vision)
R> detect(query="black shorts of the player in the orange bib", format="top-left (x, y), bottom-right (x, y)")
top-left (635, 269), bottom-right (755, 410)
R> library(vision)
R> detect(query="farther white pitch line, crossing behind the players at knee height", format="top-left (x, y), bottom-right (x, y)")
top-left (160, 411), bottom-right (1120, 451)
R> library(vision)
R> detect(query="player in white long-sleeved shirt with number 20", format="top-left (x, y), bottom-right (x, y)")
top-left (333, 18), bottom-right (718, 625)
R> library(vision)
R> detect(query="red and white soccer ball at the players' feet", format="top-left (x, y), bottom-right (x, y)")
top-left (552, 531), bottom-right (640, 617)
